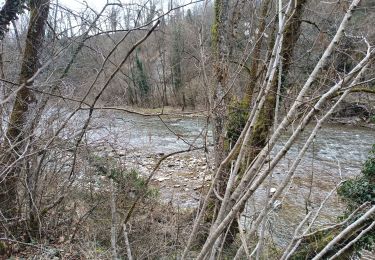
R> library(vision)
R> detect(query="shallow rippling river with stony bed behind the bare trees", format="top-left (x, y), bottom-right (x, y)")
top-left (82, 113), bottom-right (375, 247)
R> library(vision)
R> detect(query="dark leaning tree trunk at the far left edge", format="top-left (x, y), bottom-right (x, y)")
top-left (0, 0), bottom-right (49, 237)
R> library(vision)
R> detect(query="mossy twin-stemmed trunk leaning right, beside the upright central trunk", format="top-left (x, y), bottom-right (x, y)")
top-left (223, 0), bottom-right (307, 248)
